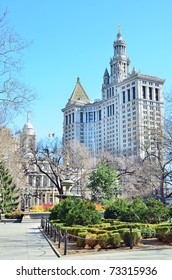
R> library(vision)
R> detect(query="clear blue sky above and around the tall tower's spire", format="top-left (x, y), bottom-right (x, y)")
top-left (0, 0), bottom-right (172, 139)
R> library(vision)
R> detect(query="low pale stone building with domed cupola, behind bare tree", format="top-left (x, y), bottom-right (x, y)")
top-left (20, 114), bottom-right (59, 208)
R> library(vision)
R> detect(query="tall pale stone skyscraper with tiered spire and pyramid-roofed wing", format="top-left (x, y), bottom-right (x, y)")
top-left (62, 28), bottom-right (164, 157)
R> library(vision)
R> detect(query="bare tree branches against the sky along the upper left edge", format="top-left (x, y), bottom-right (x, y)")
top-left (0, 11), bottom-right (34, 126)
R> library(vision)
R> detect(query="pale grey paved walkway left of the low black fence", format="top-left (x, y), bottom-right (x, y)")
top-left (0, 222), bottom-right (58, 260)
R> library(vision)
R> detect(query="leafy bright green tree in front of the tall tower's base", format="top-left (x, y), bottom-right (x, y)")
top-left (88, 161), bottom-right (118, 201)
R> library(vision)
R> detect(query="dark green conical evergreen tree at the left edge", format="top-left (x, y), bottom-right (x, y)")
top-left (0, 162), bottom-right (19, 213)
